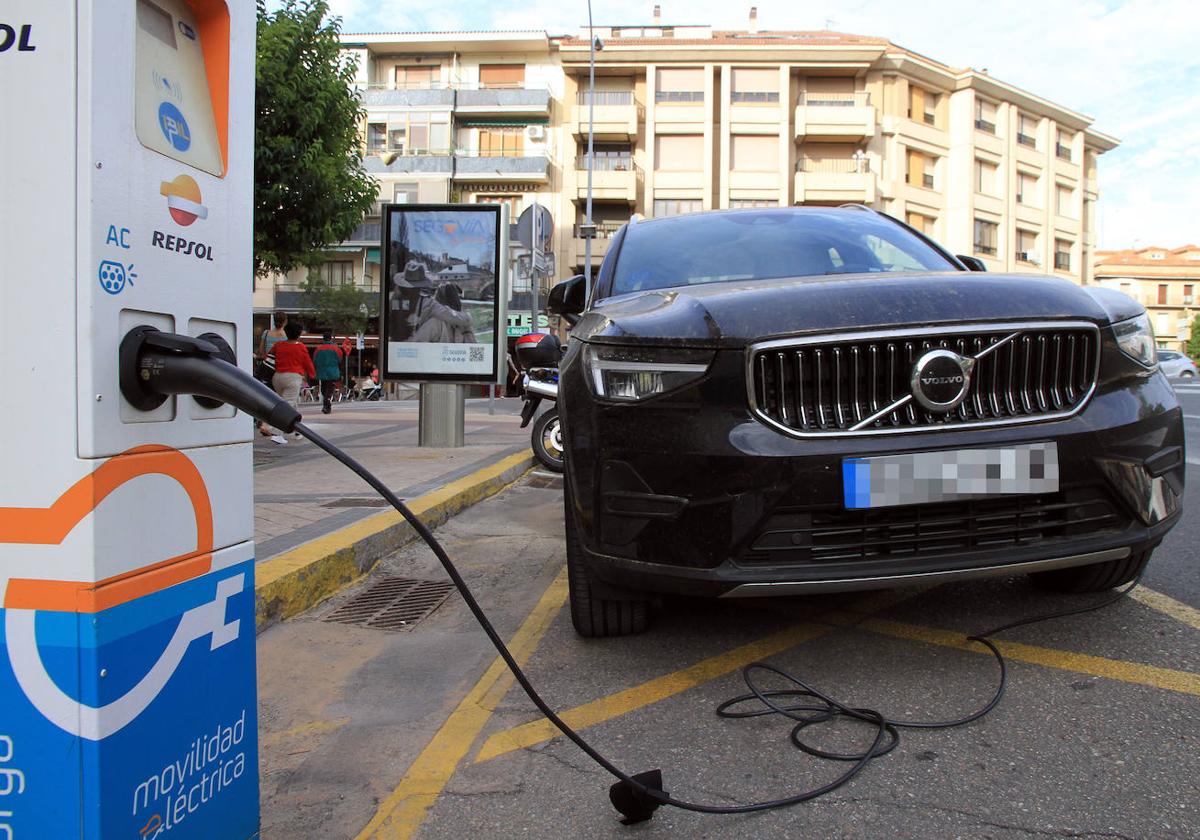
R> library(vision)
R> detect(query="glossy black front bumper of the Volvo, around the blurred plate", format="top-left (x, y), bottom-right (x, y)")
top-left (560, 345), bottom-right (1186, 596)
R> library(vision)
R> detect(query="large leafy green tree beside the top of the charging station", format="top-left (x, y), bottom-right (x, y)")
top-left (254, 0), bottom-right (379, 275)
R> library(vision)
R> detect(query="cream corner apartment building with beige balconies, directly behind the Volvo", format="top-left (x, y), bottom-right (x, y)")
top-left (558, 10), bottom-right (1117, 283)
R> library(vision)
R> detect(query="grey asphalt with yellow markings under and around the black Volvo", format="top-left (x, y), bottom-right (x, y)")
top-left (259, 384), bottom-right (1200, 839)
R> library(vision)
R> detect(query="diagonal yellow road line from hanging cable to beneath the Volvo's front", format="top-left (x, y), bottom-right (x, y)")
top-left (475, 624), bottom-right (833, 764)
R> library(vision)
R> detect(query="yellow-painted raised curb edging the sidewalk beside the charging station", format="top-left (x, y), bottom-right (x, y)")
top-left (254, 451), bottom-right (534, 632)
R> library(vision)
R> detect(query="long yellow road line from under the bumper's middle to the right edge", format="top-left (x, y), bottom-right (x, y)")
top-left (858, 618), bottom-right (1200, 695)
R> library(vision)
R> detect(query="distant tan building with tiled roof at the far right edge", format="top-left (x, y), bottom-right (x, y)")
top-left (1096, 245), bottom-right (1200, 353)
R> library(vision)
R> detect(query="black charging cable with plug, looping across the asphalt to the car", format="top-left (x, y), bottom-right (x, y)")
top-left (120, 326), bottom-right (1140, 824)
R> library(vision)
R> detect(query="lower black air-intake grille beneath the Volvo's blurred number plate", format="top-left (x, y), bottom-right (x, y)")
top-left (738, 487), bottom-right (1128, 568)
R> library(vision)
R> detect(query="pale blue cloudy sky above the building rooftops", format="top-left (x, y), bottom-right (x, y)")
top-left (330, 0), bottom-right (1200, 248)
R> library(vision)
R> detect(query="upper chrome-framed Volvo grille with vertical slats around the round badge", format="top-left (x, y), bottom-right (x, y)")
top-left (748, 323), bottom-right (1099, 437)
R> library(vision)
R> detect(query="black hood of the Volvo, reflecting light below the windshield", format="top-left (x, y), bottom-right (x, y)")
top-left (571, 271), bottom-right (1144, 347)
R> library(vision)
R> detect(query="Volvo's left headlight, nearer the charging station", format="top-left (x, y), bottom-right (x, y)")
top-left (583, 344), bottom-right (713, 402)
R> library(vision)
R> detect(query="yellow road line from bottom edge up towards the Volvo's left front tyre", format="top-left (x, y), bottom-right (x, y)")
top-left (356, 569), bottom-right (566, 840)
